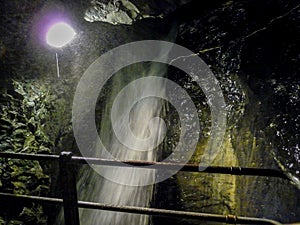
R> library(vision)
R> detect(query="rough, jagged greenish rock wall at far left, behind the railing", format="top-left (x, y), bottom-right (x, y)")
top-left (0, 80), bottom-right (59, 224)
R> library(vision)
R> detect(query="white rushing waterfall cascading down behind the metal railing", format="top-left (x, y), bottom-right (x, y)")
top-left (67, 19), bottom-right (177, 225)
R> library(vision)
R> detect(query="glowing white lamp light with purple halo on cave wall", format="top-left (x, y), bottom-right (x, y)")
top-left (46, 22), bottom-right (76, 48)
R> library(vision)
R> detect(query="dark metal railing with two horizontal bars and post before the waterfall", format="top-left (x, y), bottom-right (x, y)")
top-left (0, 152), bottom-right (296, 225)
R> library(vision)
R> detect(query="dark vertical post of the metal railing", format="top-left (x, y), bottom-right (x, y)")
top-left (59, 152), bottom-right (79, 225)
